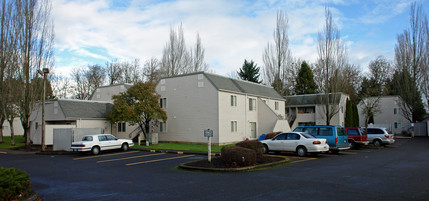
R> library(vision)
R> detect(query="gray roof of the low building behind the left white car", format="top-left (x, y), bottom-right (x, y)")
top-left (58, 99), bottom-right (113, 119)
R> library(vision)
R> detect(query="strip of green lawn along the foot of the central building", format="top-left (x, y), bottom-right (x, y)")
top-left (133, 143), bottom-right (229, 153)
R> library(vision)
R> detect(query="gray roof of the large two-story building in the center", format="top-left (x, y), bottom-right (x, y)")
top-left (162, 72), bottom-right (284, 100)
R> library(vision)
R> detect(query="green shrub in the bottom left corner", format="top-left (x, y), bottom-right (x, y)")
top-left (0, 167), bottom-right (31, 200)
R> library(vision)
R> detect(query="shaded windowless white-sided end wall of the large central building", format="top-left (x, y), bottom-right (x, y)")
top-left (154, 74), bottom-right (219, 143)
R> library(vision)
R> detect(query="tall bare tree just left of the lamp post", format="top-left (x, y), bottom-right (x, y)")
top-left (15, 0), bottom-right (54, 145)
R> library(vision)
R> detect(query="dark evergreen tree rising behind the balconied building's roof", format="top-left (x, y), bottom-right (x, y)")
top-left (295, 61), bottom-right (317, 95)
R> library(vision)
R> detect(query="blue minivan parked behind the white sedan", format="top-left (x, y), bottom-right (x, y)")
top-left (293, 126), bottom-right (350, 153)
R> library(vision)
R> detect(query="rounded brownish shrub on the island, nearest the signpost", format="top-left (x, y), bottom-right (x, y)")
top-left (221, 146), bottom-right (256, 167)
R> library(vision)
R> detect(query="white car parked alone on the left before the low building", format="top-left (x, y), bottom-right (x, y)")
top-left (70, 134), bottom-right (134, 155)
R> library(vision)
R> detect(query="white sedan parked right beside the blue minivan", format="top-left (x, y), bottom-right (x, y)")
top-left (261, 132), bottom-right (329, 157)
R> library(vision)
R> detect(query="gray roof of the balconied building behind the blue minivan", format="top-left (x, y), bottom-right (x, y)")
top-left (285, 93), bottom-right (345, 106)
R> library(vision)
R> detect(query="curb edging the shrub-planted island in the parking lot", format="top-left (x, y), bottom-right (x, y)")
top-left (179, 156), bottom-right (290, 172)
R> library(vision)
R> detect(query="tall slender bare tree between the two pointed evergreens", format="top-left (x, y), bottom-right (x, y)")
top-left (262, 11), bottom-right (294, 95)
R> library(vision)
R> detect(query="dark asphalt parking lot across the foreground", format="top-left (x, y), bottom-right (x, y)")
top-left (0, 138), bottom-right (429, 200)
